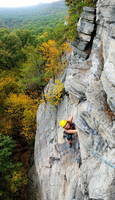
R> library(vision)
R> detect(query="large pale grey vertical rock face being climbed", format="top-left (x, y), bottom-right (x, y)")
top-left (34, 0), bottom-right (115, 200)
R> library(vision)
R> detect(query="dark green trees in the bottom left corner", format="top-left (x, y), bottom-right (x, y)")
top-left (0, 134), bottom-right (27, 200)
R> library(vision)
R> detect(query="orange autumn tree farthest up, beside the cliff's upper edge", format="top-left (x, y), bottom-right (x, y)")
top-left (39, 40), bottom-right (71, 81)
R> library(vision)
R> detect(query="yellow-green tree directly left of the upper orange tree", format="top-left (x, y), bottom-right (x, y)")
top-left (19, 46), bottom-right (46, 94)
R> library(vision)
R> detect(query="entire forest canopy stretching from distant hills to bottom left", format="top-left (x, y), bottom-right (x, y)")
top-left (0, 2), bottom-right (70, 200)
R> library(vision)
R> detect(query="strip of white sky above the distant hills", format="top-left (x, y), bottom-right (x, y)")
top-left (0, 0), bottom-right (58, 7)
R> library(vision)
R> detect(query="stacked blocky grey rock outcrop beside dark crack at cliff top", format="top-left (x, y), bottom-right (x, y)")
top-left (72, 7), bottom-right (96, 60)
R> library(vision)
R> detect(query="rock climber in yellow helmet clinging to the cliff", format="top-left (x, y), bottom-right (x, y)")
top-left (60, 117), bottom-right (77, 148)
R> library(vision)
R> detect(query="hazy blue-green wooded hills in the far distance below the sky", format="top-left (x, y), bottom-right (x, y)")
top-left (0, 1), bottom-right (67, 33)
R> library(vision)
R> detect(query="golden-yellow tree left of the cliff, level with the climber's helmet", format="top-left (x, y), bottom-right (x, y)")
top-left (6, 94), bottom-right (37, 142)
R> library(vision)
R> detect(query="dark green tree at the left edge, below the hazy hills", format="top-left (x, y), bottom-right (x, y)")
top-left (0, 29), bottom-right (25, 69)
